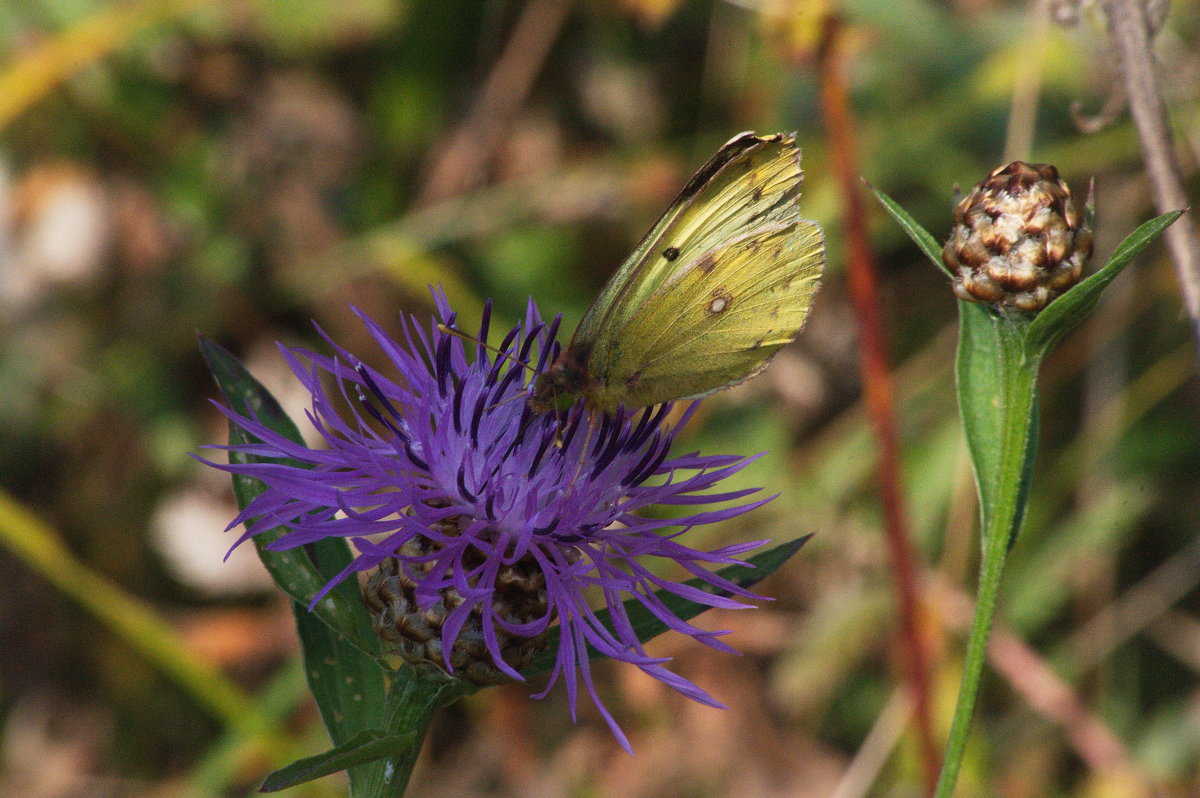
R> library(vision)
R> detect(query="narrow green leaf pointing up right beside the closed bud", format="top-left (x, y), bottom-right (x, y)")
top-left (1025, 210), bottom-right (1183, 360)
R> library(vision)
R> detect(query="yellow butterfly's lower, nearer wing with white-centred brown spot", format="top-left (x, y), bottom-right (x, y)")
top-left (588, 218), bottom-right (824, 410)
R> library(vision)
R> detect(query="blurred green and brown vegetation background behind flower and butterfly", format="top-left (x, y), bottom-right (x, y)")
top-left (0, 0), bottom-right (1200, 798)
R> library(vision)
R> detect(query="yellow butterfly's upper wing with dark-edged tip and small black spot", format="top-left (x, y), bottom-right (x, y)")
top-left (572, 133), bottom-right (804, 364)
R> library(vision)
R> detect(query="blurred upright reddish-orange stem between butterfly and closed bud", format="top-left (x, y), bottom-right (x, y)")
top-left (817, 16), bottom-right (941, 791)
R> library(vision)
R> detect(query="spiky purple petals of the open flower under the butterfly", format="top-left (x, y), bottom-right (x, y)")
top-left (205, 292), bottom-right (773, 749)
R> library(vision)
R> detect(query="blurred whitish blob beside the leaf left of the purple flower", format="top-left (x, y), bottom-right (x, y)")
top-left (150, 484), bottom-right (274, 598)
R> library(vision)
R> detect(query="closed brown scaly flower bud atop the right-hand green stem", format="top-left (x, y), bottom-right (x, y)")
top-left (942, 161), bottom-right (1092, 312)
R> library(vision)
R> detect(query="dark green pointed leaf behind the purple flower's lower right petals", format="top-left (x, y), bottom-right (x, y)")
top-left (521, 535), bottom-right (812, 677)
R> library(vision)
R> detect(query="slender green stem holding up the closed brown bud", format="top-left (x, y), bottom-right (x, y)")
top-left (934, 316), bottom-right (1039, 798)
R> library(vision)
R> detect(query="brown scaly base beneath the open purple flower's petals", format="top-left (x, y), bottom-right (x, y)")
top-left (362, 521), bottom-right (547, 685)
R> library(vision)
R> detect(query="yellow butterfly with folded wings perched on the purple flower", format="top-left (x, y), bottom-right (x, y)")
top-left (528, 133), bottom-right (824, 413)
